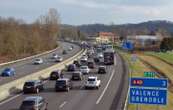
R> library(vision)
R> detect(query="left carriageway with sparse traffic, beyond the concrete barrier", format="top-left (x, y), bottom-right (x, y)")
top-left (0, 42), bottom-right (81, 85)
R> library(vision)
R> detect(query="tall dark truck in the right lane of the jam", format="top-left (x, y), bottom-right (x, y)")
top-left (103, 49), bottom-right (114, 65)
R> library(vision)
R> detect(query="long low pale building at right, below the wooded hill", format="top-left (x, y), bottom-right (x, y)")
top-left (126, 35), bottom-right (163, 50)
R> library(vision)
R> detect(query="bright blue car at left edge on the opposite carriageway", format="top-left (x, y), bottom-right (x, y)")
top-left (1, 68), bottom-right (16, 77)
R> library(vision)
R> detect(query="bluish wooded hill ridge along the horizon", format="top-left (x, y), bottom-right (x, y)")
top-left (77, 20), bottom-right (173, 35)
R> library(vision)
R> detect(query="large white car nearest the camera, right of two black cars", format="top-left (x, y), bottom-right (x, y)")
top-left (85, 76), bottom-right (101, 89)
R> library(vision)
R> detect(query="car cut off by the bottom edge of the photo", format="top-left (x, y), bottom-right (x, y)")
top-left (19, 96), bottom-right (47, 110)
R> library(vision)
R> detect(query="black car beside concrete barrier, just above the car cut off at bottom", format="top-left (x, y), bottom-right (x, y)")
top-left (23, 80), bottom-right (44, 94)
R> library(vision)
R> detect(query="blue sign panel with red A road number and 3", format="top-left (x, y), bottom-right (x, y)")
top-left (130, 78), bottom-right (168, 89)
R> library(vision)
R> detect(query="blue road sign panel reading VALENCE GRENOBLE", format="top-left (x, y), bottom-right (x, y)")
top-left (129, 88), bottom-right (167, 105)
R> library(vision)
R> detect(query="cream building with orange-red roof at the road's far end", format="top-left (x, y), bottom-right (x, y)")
top-left (96, 32), bottom-right (119, 43)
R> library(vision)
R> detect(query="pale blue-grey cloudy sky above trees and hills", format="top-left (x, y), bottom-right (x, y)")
top-left (0, 0), bottom-right (173, 25)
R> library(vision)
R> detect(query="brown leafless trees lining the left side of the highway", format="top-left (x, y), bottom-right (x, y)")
top-left (0, 9), bottom-right (60, 59)
